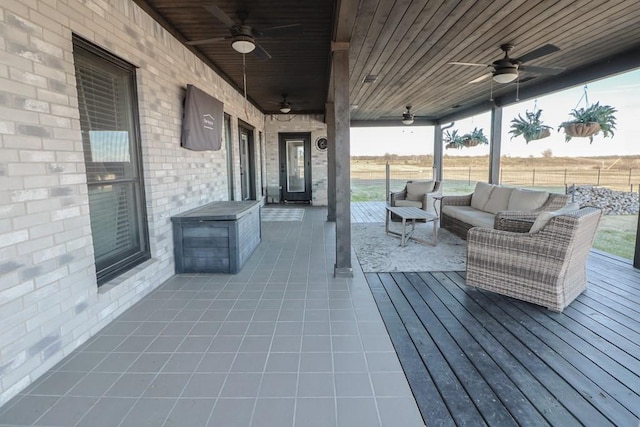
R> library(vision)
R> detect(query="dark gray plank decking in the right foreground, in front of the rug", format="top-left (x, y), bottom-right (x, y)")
top-left (366, 252), bottom-right (640, 427)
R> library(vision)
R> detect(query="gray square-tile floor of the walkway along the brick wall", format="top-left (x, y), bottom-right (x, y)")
top-left (0, 207), bottom-right (430, 427)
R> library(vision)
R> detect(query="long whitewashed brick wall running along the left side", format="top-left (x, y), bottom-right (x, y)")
top-left (0, 0), bottom-right (272, 405)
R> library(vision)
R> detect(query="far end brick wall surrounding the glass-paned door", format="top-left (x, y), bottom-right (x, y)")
top-left (265, 114), bottom-right (328, 206)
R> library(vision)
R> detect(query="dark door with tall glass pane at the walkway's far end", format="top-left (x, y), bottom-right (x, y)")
top-left (280, 133), bottom-right (311, 202)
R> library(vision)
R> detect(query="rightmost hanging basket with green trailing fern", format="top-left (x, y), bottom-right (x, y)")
top-left (558, 102), bottom-right (617, 143)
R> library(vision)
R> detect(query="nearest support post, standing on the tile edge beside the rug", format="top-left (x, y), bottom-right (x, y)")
top-left (331, 42), bottom-right (353, 277)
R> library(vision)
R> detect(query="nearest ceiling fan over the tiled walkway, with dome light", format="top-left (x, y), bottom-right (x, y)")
top-left (187, 5), bottom-right (302, 59)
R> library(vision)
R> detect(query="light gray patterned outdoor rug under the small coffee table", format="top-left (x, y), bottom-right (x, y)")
top-left (351, 223), bottom-right (467, 273)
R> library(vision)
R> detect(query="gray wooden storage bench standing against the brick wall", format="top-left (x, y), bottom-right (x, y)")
top-left (171, 201), bottom-right (261, 273)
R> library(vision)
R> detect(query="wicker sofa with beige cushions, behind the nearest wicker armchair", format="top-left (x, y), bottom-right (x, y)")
top-left (440, 182), bottom-right (569, 239)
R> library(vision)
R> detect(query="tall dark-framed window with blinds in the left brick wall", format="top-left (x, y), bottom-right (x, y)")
top-left (73, 37), bottom-right (150, 285)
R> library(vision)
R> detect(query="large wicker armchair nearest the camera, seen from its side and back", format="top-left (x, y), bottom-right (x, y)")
top-left (466, 207), bottom-right (602, 311)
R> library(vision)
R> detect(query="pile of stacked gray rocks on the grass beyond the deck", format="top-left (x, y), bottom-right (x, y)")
top-left (568, 185), bottom-right (638, 215)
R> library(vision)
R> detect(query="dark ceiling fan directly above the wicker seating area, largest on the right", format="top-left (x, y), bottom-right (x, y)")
top-left (449, 43), bottom-right (564, 83)
